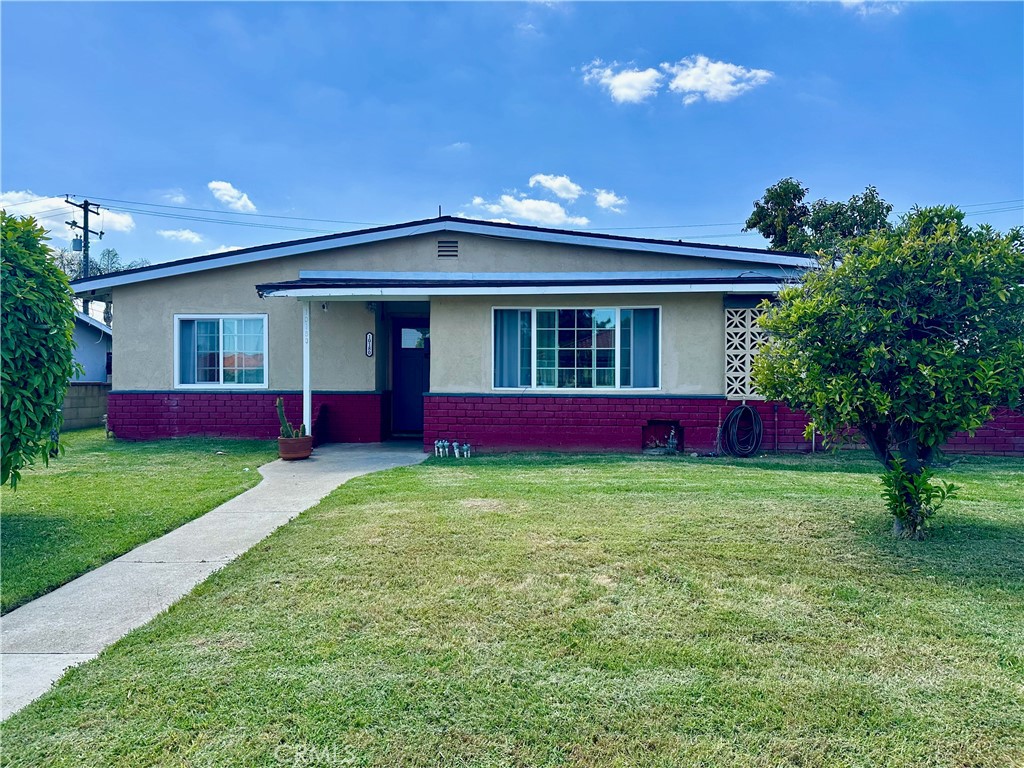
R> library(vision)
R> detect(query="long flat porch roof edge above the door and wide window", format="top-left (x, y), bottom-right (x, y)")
top-left (256, 266), bottom-right (799, 298)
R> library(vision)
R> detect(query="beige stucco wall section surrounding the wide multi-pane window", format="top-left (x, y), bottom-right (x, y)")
top-left (430, 294), bottom-right (725, 395)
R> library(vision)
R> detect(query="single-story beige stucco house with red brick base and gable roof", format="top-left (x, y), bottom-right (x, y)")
top-left (73, 216), bottom-right (1024, 451)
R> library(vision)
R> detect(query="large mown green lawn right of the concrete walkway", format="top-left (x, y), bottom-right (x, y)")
top-left (2, 455), bottom-right (1024, 768)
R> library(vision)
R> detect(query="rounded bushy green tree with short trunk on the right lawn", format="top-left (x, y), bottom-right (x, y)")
top-left (754, 207), bottom-right (1024, 539)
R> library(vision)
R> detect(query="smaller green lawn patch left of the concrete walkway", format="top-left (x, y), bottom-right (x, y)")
top-left (0, 429), bottom-right (276, 612)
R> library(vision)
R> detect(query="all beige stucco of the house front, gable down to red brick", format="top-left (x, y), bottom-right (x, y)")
top-left (113, 233), bottom-right (749, 394)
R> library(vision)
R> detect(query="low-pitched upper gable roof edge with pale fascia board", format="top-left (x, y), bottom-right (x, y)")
top-left (72, 216), bottom-right (816, 294)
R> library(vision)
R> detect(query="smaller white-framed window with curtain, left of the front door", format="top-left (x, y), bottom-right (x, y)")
top-left (174, 314), bottom-right (267, 388)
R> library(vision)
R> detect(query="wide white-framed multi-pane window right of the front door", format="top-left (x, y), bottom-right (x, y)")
top-left (494, 307), bottom-right (660, 389)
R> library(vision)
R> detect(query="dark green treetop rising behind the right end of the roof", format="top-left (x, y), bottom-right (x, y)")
top-left (743, 178), bottom-right (893, 264)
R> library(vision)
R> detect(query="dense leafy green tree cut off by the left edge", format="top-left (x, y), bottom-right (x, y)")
top-left (0, 211), bottom-right (81, 487)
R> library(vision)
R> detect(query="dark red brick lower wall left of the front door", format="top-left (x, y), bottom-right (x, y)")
top-left (106, 392), bottom-right (387, 442)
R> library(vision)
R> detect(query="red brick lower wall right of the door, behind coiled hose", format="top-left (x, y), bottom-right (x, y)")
top-left (423, 395), bottom-right (1024, 456)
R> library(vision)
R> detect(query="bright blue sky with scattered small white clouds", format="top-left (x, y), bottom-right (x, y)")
top-left (0, 2), bottom-right (1024, 263)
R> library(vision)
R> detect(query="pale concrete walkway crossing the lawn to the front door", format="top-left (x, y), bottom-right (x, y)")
top-left (0, 442), bottom-right (427, 719)
